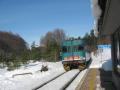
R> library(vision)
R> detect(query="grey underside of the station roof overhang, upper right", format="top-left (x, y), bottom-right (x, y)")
top-left (101, 0), bottom-right (120, 35)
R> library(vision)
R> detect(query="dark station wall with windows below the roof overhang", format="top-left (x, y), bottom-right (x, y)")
top-left (111, 28), bottom-right (120, 90)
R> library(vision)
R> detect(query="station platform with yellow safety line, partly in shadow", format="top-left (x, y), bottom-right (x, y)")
top-left (76, 68), bottom-right (116, 90)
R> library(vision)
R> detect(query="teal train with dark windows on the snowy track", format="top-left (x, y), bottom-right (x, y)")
top-left (60, 39), bottom-right (91, 71)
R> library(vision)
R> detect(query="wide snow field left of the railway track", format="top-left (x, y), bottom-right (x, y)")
top-left (0, 62), bottom-right (65, 90)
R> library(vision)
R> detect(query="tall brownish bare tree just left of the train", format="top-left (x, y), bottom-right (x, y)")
top-left (40, 29), bottom-right (66, 60)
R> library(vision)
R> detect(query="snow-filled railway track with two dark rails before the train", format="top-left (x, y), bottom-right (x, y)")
top-left (32, 69), bottom-right (80, 90)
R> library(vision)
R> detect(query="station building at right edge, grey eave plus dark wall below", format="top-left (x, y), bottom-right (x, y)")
top-left (97, 0), bottom-right (120, 90)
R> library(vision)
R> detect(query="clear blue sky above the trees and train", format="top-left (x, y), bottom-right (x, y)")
top-left (0, 0), bottom-right (94, 44)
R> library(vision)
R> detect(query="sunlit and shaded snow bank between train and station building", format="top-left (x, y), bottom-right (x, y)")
top-left (90, 49), bottom-right (112, 71)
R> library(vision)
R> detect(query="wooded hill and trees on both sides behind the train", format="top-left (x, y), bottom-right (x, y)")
top-left (0, 29), bottom-right (110, 70)
